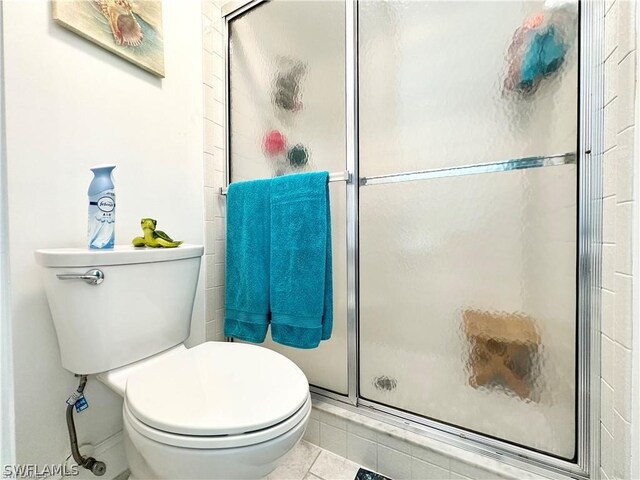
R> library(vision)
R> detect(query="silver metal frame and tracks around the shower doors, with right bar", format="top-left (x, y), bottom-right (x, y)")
top-left (222, 0), bottom-right (604, 479)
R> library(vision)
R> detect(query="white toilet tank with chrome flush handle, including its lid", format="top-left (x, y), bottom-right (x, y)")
top-left (35, 248), bottom-right (204, 374)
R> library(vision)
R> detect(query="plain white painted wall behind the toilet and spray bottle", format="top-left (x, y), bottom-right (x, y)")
top-left (3, 0), bottom-right (204, 464)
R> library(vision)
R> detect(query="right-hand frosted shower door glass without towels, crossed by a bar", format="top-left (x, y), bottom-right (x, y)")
top-left (359, 1), bottom-right (578, 459)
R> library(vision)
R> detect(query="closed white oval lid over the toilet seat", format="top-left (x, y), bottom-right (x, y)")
top-left (125, 342), bottom-right (309, 436)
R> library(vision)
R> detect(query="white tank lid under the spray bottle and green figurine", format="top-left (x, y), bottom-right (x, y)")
top-left (35, 243), bottom-right (204, 267)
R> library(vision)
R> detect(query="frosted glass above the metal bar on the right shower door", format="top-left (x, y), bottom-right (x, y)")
top-left (359, 0), bottom-right (578, 176)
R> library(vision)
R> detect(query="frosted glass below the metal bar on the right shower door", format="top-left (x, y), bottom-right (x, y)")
top-left (360, 165), bottom-right (577, 458)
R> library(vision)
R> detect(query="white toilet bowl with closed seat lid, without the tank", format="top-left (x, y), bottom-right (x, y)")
top-left (98, 342), bottom-right (311, 480)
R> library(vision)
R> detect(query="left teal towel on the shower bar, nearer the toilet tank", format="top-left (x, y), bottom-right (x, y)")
top-left (224, 180), bottom-right (271, 343)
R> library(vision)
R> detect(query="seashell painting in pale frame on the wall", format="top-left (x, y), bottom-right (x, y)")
top-left (52, 0), bottom-right (164, 77)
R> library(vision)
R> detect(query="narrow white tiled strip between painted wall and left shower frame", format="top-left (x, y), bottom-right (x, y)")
top-left (202, 0), bottom-right (226, 340)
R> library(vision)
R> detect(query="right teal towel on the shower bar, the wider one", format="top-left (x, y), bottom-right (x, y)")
top-left (270, 172), bottom-right (333, 348)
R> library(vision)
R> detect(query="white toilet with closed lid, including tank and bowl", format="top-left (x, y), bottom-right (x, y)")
top-left (35, 245), bottom-right (311, 480)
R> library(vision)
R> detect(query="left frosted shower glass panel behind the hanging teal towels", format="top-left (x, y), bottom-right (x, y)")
top-left (229, 0), bottom-right (347, 394)
